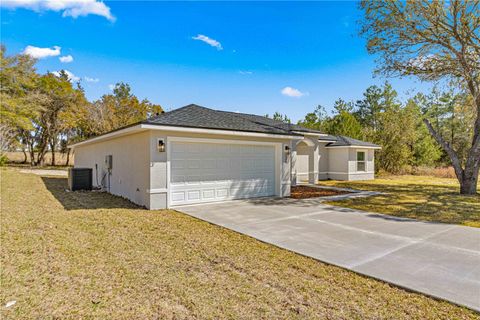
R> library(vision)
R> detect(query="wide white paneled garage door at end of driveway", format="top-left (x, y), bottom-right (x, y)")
top-left (170, 142), bottom-right (275, 205)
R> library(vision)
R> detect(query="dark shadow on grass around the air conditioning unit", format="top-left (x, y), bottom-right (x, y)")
top-left (42, 176), bottom-right (142, 210)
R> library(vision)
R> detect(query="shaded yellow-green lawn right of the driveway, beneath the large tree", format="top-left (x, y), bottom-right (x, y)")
top-left (320, 175), bottom-right (480, 227)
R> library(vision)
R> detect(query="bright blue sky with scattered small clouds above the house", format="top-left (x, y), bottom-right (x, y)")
top-left (1, 0), bottom-right (425, 121)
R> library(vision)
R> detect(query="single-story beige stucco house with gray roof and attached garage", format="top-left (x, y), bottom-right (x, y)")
top-left (70, 104), bottom-right (380, 209)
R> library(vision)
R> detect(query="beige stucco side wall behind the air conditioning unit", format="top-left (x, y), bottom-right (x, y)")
top-left (74, 132), bottom-right (150, 207)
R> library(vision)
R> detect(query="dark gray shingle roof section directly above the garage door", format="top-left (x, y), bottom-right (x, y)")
top-left (144, 104), bottom-right (320, 135)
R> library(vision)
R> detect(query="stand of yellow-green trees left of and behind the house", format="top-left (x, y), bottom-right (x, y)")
top-left (0, 46), bottom-right (163, 169)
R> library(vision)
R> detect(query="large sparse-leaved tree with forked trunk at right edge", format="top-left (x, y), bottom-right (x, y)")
top-left (360, 0), bottom-right (480, 194)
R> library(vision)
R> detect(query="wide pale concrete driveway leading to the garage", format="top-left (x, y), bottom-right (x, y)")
top-left (175, 199), bottom-right (480, 311)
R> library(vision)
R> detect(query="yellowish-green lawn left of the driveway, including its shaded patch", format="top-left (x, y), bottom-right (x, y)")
top-left (0, 169), bottom-right (478, 319)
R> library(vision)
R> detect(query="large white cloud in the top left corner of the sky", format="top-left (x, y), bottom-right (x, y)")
top-left (1, 0), bottom-right (115, 21)
